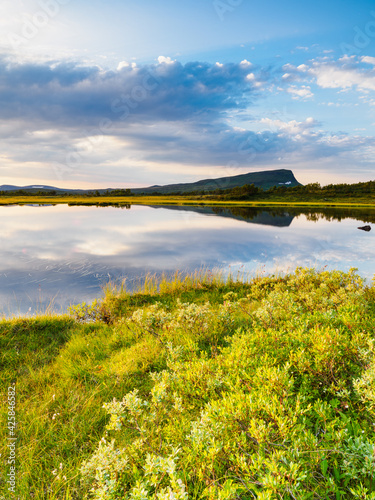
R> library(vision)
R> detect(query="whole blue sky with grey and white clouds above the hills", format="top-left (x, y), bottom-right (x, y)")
top-left (0, 0), bottom-right (375, 189)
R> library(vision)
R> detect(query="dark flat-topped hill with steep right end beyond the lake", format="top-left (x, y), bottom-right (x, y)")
top-left (132, 169), bottom-right (302, 194)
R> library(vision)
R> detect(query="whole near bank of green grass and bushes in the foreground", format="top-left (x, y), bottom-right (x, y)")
top-left (0, 269), bottom-right (375, 500)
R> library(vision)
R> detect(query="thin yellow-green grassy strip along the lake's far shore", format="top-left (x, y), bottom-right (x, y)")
top-left (0, 195), bottom-right (375, 208)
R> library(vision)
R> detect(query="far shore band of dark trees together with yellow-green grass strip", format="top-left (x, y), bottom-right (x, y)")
top-left (0, 181), bottom-right (375, 207)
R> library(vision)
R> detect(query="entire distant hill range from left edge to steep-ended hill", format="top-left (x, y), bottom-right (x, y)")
top-left (0, 169), bottom-right (302, 195)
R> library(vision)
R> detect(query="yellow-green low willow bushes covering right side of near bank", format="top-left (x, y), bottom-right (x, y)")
top-left (78, 269), bottom-right (375, 500)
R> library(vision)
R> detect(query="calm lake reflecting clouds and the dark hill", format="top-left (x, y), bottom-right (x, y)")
top-left (0, 205), bottom-right (375, 316)
